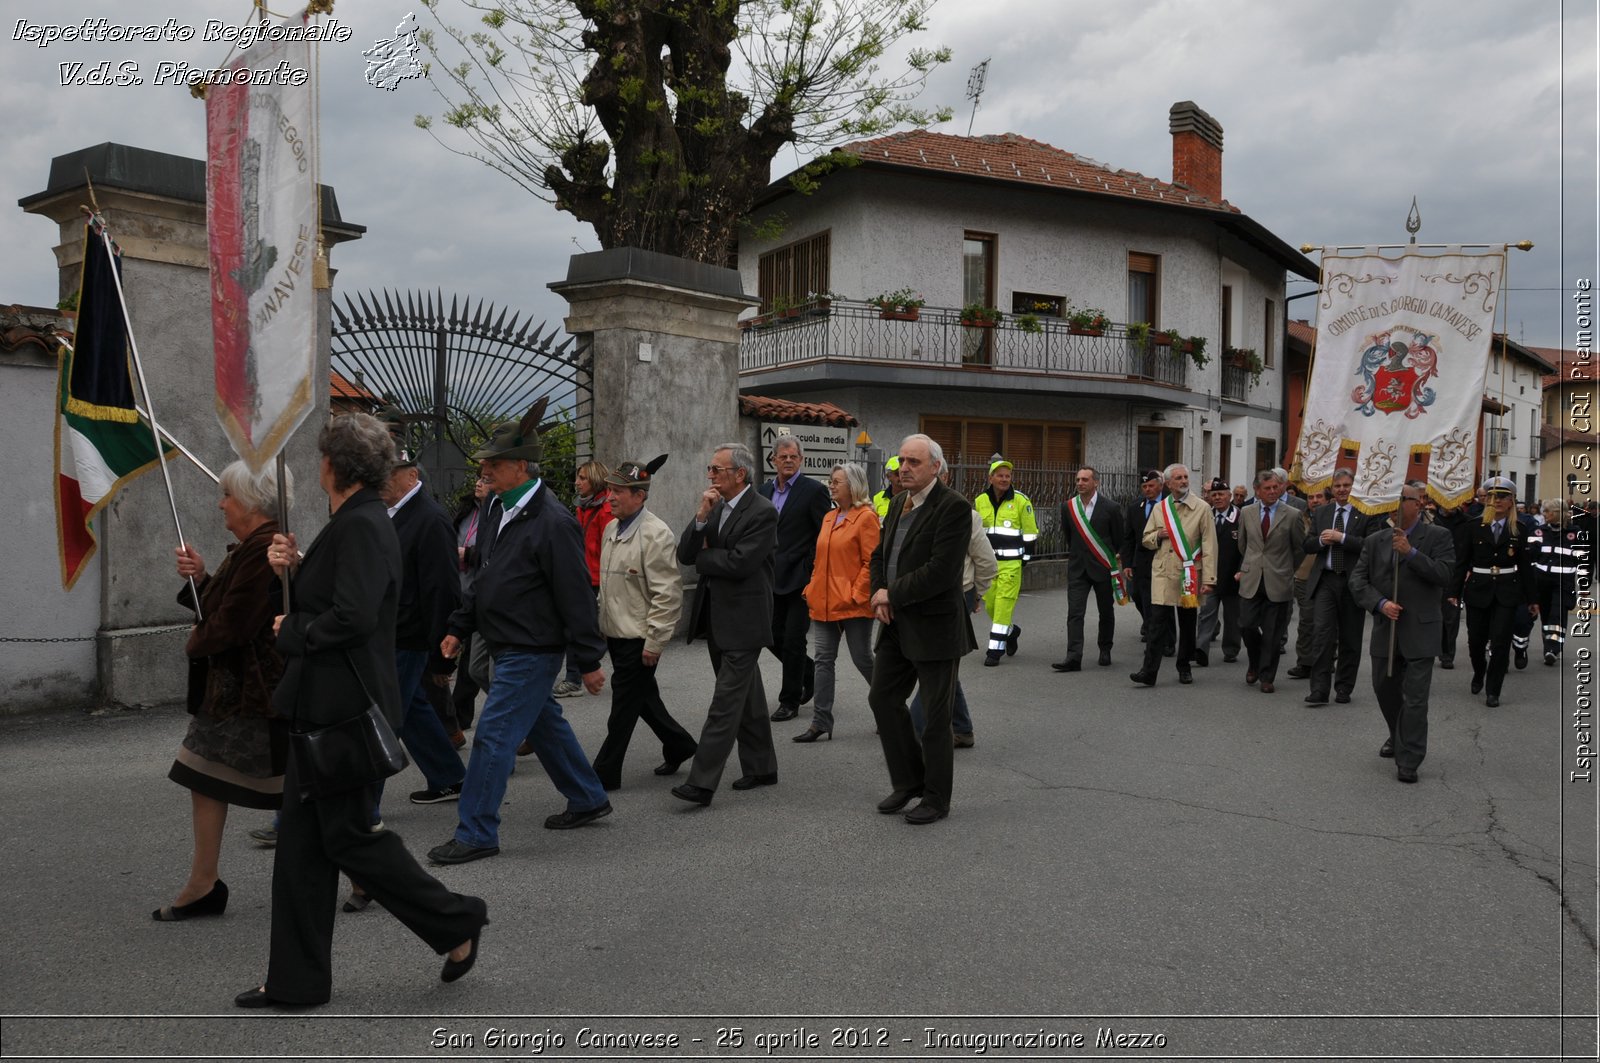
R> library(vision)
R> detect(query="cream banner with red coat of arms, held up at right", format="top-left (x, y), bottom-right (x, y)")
top-left (1299, 250), bottom-right (1506, 512)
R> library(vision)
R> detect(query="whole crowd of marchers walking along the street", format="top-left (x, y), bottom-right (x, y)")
top-left (154, 406), bottom-right (1595, 1007)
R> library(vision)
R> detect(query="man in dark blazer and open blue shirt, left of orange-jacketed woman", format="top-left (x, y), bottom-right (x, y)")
top-left (757, 435), bottom-right (832, 720)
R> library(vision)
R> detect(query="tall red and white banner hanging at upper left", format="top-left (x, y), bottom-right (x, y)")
top-left (206, 14), bottom-right (317, 471)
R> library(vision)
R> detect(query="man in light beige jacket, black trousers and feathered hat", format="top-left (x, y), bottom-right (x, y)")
top-left (595, 455), bottom-right (694, 789)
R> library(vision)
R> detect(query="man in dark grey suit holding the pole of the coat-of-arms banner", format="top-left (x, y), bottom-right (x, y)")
top-left (1350, 480), bottom-right (1456, 783)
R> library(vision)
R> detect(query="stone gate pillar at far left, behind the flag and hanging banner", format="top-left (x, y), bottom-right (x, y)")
top-left (19, 144), bottom-right (365, 704)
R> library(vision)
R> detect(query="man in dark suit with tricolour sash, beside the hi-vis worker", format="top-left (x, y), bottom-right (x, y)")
top-left (1051, 466), bottom-right (1128, 672)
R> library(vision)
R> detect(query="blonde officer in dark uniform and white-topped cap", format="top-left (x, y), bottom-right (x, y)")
top-left (1453, 475), bottom-right (1539, 709)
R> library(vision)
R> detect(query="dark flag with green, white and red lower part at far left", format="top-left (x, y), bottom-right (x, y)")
top-left (56, 227), bottom-right (173, 591)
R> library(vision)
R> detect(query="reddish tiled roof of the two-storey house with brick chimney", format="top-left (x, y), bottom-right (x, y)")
top-left (840, 130), bottom-right (1240, 215)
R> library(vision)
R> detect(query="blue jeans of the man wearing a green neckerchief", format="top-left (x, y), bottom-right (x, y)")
top-left (456, 650), bottom-right (606, 848)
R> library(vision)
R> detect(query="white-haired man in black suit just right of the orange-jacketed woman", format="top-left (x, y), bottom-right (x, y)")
top-left (867, 434), bottom-right (978, 824)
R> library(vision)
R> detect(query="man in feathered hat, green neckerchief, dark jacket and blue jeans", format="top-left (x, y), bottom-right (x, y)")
top-left (427, 416), bottom-right (611, 864)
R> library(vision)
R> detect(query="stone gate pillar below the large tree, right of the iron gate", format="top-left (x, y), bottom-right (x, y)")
top-left (550, 248), bottom-right (760, 532)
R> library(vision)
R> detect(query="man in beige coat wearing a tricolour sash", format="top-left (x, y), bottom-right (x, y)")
top-left (1128, 464), bottom-right (1216, 687)
